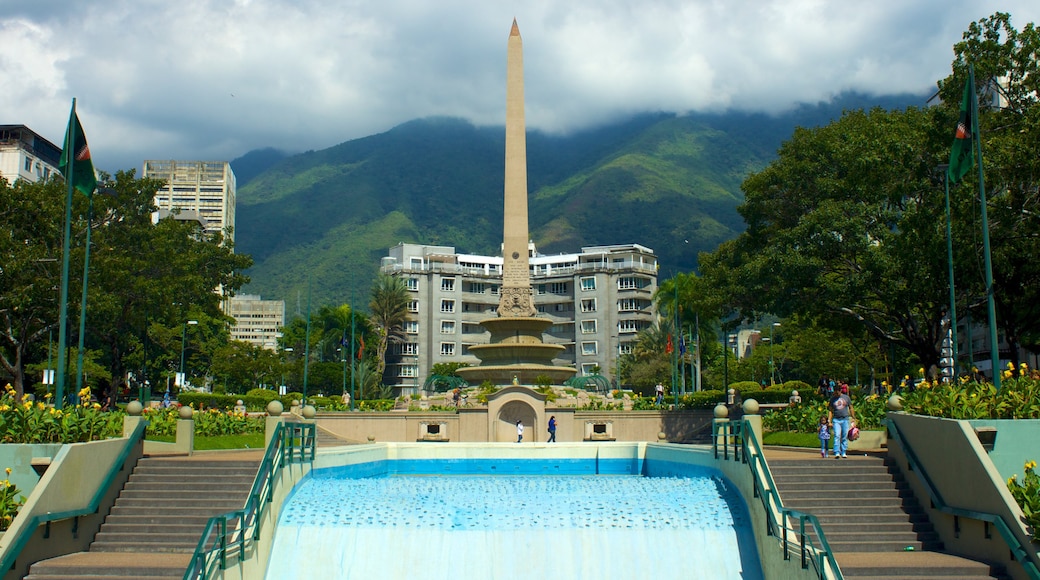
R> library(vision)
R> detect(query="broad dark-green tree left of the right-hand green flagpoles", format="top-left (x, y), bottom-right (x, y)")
top-left (701, 104), bottom-right (953, 370)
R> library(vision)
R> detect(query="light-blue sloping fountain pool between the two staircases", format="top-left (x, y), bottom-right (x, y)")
top-left (267, 466), bottom-right (761, 580)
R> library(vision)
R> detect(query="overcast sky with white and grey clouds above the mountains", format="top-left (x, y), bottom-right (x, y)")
top-left (0, 0), bottom-right (1040, 172)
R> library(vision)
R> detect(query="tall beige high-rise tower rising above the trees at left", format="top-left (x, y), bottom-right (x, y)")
top-left (141, 160), bottom-right (237, 242)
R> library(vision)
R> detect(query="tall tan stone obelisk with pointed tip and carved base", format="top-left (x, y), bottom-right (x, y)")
top-left (498, 19), bottom-right (538, 317)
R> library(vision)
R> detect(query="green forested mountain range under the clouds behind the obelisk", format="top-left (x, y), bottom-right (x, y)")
top-left (231, 94), bottom-right (924, 315)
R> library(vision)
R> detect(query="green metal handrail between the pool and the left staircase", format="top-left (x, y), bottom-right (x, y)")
top-left (184, 423), bottom-right (316, 580)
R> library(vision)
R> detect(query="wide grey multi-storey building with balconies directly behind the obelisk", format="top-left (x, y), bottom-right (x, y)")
top-left (382, 243), bottom-right (657, 389)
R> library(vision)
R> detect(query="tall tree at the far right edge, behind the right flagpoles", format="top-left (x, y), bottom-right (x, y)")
top-left (940, 12), bottom-right (1040, 367)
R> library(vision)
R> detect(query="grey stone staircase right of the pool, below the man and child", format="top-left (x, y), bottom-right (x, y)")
top-left (766, 452), bottom-right (1005, 580)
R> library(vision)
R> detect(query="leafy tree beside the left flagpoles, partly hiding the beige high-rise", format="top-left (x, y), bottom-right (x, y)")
top-left (87, 170), bottom-right (253, 403)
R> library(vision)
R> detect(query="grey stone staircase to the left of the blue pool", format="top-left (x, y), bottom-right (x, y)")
top-left (26, 453), bottom-right (260, 580)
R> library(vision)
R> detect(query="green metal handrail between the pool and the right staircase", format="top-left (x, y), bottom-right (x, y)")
top-left (711, 420), bottom-right (843, 580)
